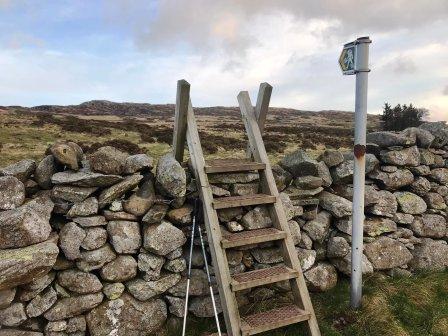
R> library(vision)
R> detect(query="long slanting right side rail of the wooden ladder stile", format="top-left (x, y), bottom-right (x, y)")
top-left (238, 91), bottom-right (320, 336)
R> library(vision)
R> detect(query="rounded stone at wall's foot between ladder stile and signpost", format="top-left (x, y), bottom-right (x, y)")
top-left (303, 262), bottom-right (338, 292)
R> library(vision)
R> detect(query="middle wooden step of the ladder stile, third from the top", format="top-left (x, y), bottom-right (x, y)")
top-left (221, 228), bottom-right (286, 248)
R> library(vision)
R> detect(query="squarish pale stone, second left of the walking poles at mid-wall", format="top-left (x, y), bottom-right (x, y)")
top-left (107, 221), bottom-right (142, 253)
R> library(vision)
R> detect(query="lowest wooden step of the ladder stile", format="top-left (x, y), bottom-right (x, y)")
top-left (241, 305), bottom-right (311, 336)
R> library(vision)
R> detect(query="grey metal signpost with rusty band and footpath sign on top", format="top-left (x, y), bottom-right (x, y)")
top-left (339, 37), bottom-right (372, 309)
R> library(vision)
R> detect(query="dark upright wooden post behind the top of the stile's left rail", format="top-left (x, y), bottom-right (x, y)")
top-left (173, 79), bottom-right (190, 163)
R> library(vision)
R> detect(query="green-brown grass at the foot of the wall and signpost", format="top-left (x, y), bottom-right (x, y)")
top-left (169, 272), bottom-right (448, 336)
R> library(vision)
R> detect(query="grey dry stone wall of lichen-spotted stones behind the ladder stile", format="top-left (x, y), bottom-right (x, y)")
top-left (0, 123), bottom-right (448, 336)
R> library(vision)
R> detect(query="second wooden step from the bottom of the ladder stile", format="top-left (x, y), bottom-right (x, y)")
top-left (230, 266), bottom-right (299, 291)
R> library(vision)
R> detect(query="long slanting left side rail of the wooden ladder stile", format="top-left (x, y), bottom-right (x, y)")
top-left (187, 101), bottom-right (240, 336)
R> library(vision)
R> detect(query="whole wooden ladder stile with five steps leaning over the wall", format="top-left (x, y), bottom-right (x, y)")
top-left (173, 80), bottom-right (320, 336)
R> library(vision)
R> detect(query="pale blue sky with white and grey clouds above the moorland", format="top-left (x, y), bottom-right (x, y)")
top-left (0, 0), bottom-right (448, 120)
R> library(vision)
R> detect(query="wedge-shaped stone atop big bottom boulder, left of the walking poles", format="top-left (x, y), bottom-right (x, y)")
top-left (126, 273), bottom-right (181, 301)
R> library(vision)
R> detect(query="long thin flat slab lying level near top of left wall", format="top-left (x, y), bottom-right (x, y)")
top-left (51, 170), bottom-right (123, 188)
